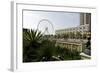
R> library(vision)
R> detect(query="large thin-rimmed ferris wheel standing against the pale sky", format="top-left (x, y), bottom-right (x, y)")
top-left (37, 19), bottom-right (55, 35)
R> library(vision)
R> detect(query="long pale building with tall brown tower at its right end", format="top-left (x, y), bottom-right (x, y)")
top-left (55, 13), bottom-right (91, 34)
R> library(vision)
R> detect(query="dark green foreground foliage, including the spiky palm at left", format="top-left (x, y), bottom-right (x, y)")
top-left (23, 29), bottom-right (81, 62)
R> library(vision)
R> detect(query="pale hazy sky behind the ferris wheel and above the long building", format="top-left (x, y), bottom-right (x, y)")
top-left (23, 11), bottom-right (80, 34)
